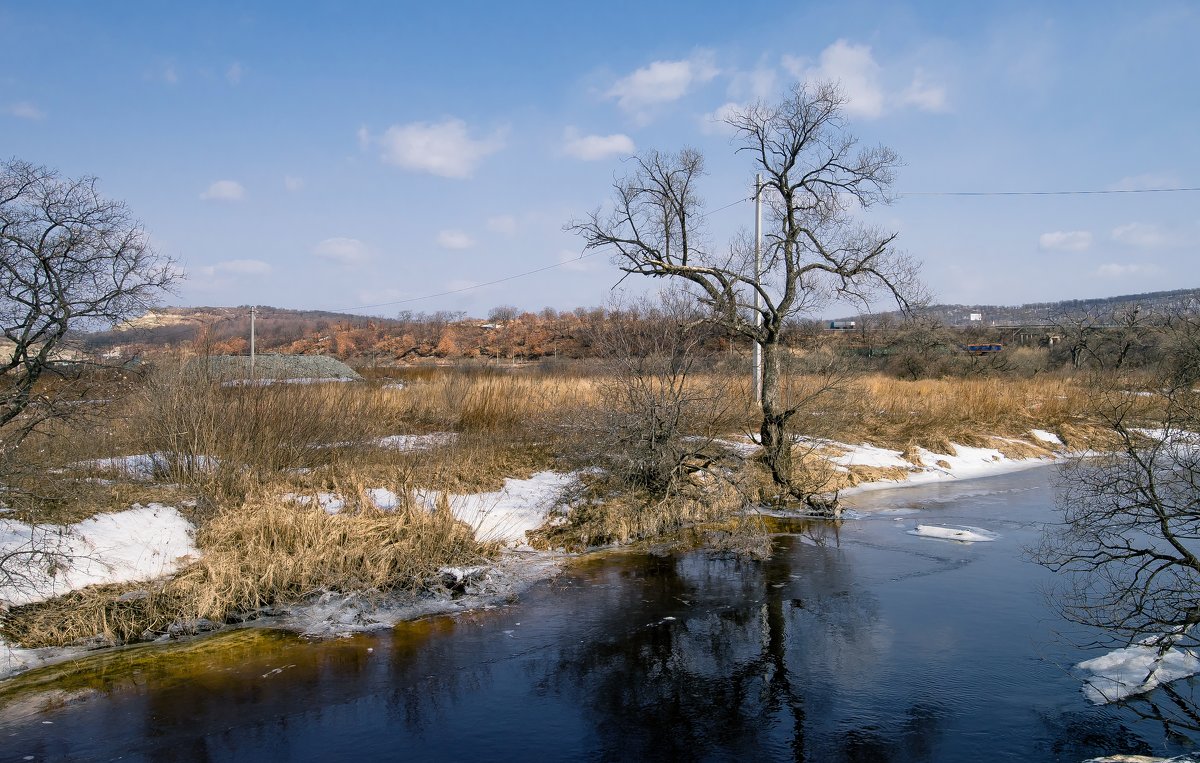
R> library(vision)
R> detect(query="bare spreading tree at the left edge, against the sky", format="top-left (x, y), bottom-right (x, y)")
top-left (0, 160), bottom-right (176, 446)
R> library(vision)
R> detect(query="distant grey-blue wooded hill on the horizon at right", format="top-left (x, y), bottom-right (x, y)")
top-left (846, 289), bottom-right (1200, 326)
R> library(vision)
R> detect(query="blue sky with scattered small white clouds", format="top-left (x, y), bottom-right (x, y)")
top-left (0, 1), bottom-right (1200, 316)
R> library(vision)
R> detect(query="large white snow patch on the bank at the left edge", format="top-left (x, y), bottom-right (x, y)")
top-left (0, 504), bottom-right (199, 606)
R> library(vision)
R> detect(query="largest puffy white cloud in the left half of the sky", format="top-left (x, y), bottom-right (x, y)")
top-left (374, 118), bottom-right (504, 178)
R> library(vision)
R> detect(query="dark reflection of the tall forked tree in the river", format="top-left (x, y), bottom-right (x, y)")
top-left (539, 525), bottom-right (941, 761)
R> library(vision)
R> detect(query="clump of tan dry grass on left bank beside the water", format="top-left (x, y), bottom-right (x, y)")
top-left (0, 486), bottom-right (496, 647)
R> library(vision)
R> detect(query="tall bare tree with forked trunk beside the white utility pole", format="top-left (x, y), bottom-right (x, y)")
top-left (568, 84), bottom-right (919, 513)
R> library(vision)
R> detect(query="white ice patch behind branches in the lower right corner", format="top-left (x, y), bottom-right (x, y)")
top-left (1075, 643), bottom-right (1200, 704)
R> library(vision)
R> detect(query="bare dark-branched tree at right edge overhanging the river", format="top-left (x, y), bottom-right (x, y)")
top-left (1036, 305), bottom-right (1200, 705)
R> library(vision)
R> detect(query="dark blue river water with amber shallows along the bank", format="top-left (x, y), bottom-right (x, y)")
top-left (0, 469), bottom-right (1192, 761)
